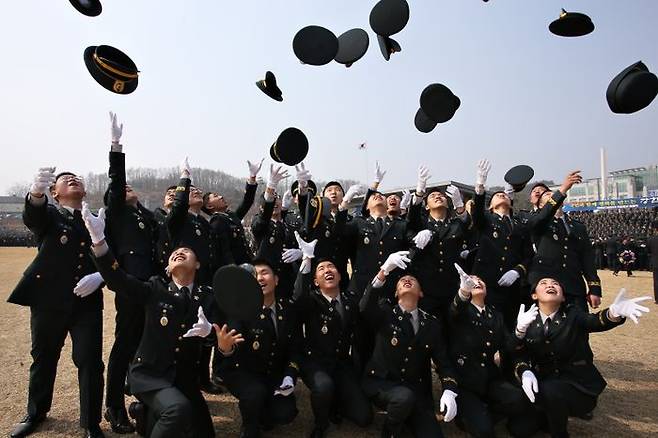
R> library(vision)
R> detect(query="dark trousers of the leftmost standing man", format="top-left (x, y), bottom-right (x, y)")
top-left (27, 306), bottom-right (104, 428)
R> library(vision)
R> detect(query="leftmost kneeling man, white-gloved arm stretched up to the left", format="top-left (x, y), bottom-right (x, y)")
top-left (83, 206), bottom-right (217, 438)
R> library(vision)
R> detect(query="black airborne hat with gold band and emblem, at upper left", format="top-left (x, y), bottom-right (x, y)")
top-left (84, 45), bottom-right (139, 94)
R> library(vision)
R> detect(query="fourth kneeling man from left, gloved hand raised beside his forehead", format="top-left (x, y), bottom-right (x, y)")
top-left (360, 251), bottom-right (457, 437)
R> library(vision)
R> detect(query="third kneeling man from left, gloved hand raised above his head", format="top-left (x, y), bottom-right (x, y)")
top-left (293, 233), bottom-right (372, 438)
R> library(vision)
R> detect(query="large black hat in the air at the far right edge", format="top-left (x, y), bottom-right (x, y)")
top-left (606, 61), bottom-right (658, 114)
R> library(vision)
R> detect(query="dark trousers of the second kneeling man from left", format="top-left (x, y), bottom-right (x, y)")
top-left (223, 371), bottom-right (298, 437)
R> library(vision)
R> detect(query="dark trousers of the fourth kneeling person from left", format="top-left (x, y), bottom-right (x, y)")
top-left (362, 377), bottom-right (443, 438)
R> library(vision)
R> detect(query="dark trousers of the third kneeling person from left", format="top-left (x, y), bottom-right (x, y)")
top-left (301, 360), bottom-right (373, 429)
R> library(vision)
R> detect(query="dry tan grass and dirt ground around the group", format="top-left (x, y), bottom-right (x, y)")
top-left (0, 248), bottom-right (658, 437)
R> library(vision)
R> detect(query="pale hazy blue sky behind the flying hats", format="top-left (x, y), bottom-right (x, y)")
top-left (0, 0), bottom-right (658, 192)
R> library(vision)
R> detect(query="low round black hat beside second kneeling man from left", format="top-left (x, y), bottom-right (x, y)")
top-left (213, 265), bottom-right (263, 321)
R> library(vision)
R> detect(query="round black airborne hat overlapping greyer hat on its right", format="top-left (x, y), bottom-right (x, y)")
top-left (292, 26), bottom-right (338, 65)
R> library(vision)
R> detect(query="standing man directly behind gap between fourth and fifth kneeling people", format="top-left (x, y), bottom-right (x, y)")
top-left (407, 168), bottom-right (470, 330)
